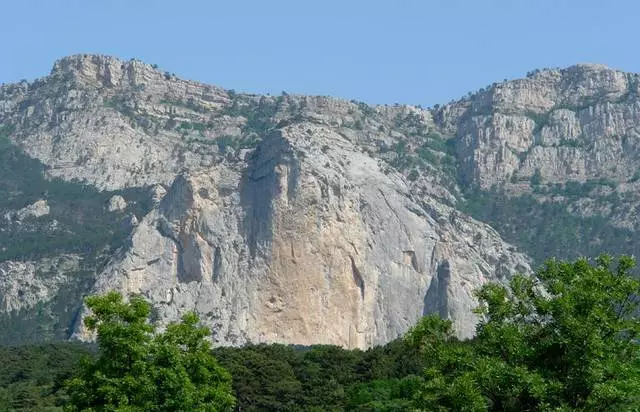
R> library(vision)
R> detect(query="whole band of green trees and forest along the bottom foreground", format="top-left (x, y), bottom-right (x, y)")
top-left (0, 256), bottom-right (640, 411)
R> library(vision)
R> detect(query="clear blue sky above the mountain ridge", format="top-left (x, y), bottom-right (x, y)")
top-left (0, 0), bottom-right (640, 106)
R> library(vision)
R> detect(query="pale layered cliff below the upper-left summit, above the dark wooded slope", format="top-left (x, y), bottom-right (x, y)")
top-left (0, 55), bottom-right (228, 189)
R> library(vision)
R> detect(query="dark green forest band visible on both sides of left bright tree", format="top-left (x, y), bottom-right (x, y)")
top-left (0, 339), bottom-right (423, 411)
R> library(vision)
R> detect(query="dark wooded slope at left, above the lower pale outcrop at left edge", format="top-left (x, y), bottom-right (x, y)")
top-left (0, 134), bottom-right (151, 260)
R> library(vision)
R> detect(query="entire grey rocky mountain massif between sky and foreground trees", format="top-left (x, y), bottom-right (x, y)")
top-left (0, 55), bottom-right (640, 347)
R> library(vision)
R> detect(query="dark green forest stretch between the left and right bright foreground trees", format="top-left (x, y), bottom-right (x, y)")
top-left (214, 339), bottom-right (423, 411)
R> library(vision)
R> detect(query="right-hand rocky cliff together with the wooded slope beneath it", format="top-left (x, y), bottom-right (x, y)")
top-left (433, 64), bottom-right (640, 263)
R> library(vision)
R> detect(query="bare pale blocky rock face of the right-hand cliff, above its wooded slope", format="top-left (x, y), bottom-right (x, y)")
top-left (435, 65), bottom-right (640, 189)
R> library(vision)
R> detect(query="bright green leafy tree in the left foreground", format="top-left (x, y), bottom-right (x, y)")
top-left (66, 292), bottom-right (234, 411)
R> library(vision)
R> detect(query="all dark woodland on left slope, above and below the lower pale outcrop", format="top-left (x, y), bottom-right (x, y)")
top-left (0, 132), bottom-right (152, 344)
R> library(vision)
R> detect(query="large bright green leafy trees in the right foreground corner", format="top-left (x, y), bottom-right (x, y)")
top-left (408, 255), bottom-right (640, 411)
